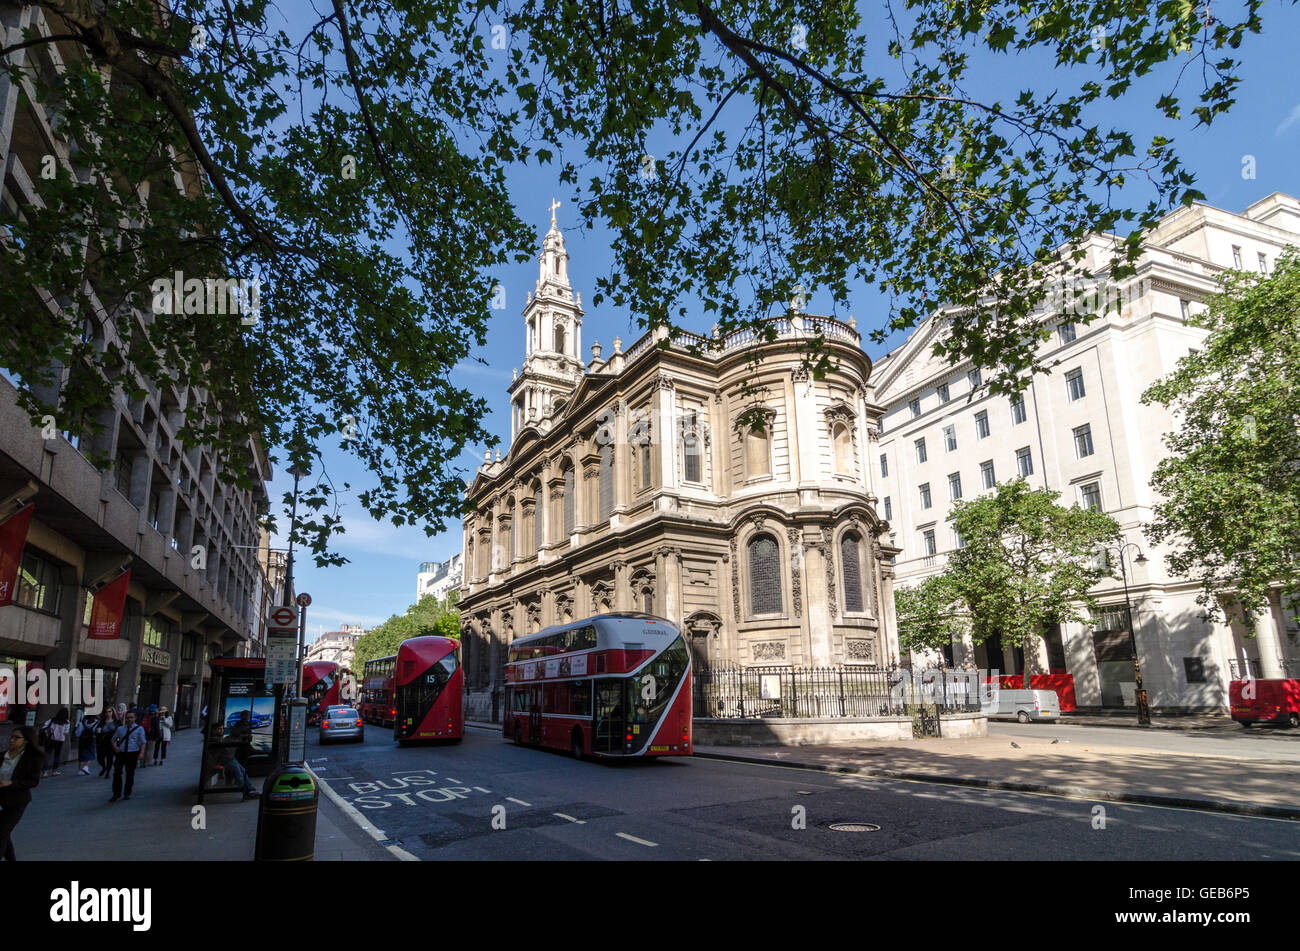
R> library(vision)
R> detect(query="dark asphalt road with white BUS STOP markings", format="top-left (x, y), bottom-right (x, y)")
top-left (308, 726), bottom-right (1300, 861)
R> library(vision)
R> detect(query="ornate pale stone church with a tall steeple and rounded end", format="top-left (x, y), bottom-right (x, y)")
top-left (460, 217), bottom-right (897, 706)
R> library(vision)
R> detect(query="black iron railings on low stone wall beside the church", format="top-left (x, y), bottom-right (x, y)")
top-left (693, 666), bottom-right (980, 717)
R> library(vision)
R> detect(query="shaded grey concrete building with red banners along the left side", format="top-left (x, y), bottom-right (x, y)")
top-left (0, 4), bottom-right (270, 746)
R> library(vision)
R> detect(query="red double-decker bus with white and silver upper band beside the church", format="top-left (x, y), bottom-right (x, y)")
top-left (502, 613), bottom-right (692, 757)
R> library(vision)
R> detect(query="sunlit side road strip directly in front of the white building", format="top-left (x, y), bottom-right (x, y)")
top-left (988, 720), bottom-right (1300, 763)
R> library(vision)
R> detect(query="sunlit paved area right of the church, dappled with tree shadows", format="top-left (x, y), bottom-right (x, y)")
top-left (476, 717), bottom-right (1300, 818)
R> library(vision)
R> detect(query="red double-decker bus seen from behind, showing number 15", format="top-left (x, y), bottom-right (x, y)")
top-left (393, 637), bottom-right (465, 744)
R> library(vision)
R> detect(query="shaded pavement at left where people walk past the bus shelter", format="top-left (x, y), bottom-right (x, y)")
top-left (13, 730), bottom-right (394, 861)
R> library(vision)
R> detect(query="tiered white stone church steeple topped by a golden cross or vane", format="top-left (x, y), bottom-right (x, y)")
top-left (508, 200), bottom-right (584, 440)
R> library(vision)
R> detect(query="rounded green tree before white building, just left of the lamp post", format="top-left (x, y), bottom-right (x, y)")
top-left (945, 478), bottom-right (1119, 673)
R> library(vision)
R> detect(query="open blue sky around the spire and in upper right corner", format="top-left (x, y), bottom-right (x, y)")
top-left (284, 4), bottom-right (1300, 639)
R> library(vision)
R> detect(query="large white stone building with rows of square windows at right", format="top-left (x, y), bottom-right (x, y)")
top-left (870, 194), bottom-right (1300, 711)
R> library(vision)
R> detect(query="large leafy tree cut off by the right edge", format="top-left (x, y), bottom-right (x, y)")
top-left (1143, 248), bottom-right (1300, 616)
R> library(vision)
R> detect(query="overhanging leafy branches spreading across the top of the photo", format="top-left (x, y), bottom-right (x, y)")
top-left (0, 0), bottom-right (1279, 564)
